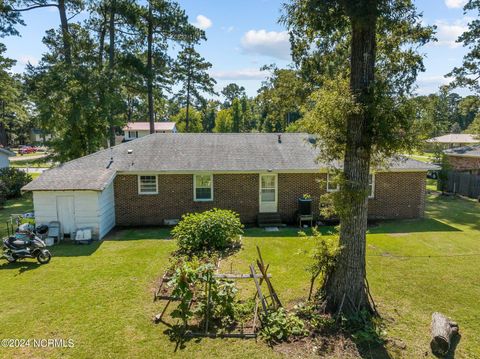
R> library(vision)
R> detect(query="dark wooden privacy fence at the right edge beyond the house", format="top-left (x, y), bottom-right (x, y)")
top-left (439, 171), bottom-right (480, 198)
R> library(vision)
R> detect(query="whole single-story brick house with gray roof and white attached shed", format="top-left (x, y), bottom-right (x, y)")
top-left (23, 133), bottom-right (433, 238)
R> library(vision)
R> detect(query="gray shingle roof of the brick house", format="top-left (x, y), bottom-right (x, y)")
top-left (23, 133), bottom-right (436, 191)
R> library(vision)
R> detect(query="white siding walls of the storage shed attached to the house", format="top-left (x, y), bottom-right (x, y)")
top-left (33, 183), bottom-right (115, 239)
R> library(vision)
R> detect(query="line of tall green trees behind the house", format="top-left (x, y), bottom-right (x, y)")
top-left (0, 0), bottom-right (480, 161)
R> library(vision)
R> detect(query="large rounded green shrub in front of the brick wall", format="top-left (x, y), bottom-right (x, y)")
top-left (172, 208), bottom-right (243, 254)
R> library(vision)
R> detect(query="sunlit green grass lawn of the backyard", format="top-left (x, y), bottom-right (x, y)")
top-left (0, 196), bottom-right (480, 358)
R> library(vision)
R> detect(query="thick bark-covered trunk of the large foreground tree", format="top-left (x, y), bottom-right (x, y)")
top-left (324, 4), bottom-right (376, 314)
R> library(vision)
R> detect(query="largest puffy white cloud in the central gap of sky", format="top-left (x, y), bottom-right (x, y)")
top-left (241, 30), bottom-right (291, 60)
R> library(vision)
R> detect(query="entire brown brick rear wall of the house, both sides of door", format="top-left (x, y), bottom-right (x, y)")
top-left (115, 172), bottom-right (425, 226)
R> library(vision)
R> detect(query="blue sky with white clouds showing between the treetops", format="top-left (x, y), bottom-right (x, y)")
top-left (0, 0), bottom-right (476, 96)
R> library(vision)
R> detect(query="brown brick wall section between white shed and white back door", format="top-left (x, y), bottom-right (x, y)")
top-left (115, 174), bottom-right (259, 226)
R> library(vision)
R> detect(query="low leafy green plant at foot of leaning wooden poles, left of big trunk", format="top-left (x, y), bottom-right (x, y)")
top-left (260, 308), bottom-right (307, 345)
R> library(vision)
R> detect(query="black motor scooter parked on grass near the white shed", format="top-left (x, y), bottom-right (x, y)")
top-left (0, 224), bottom-right (52, 264)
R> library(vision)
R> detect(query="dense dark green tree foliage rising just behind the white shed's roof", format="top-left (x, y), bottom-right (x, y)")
top-left (27, 25), bottom-right (108, 162)
